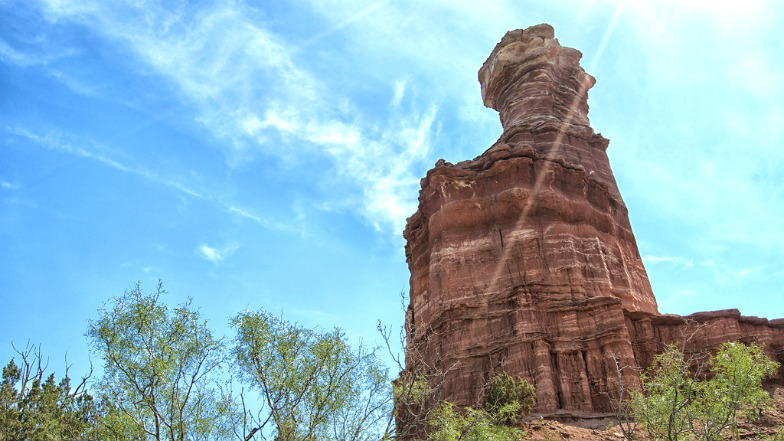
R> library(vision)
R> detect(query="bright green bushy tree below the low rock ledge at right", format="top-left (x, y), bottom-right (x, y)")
top-left (632, 342), bottom-right (778, 441)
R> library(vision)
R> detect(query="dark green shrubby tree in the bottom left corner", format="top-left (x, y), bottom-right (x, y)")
top-left (0, 345), bottom-right (97, 441)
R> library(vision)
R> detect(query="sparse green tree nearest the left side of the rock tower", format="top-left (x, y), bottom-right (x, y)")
top-left (232, 311), bottom-right (392, 441)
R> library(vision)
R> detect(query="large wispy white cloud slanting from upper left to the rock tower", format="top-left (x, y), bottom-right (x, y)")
top-left (33, 1), bottom-right (437, 235)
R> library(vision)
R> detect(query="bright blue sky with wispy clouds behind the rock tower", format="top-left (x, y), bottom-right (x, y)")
top-left (0, 0), bottom-right (784, 373)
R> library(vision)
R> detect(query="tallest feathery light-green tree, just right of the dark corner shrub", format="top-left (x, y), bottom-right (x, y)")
top-left (87, 282), bottom-right (232, 441)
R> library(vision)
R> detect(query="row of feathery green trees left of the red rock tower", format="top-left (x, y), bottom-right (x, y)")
top-left (0, 283), bottom-right (394, 441)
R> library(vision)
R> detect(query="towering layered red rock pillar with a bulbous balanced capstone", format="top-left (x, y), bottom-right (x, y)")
top-left (404, 25), bottom-right (784, 418)
